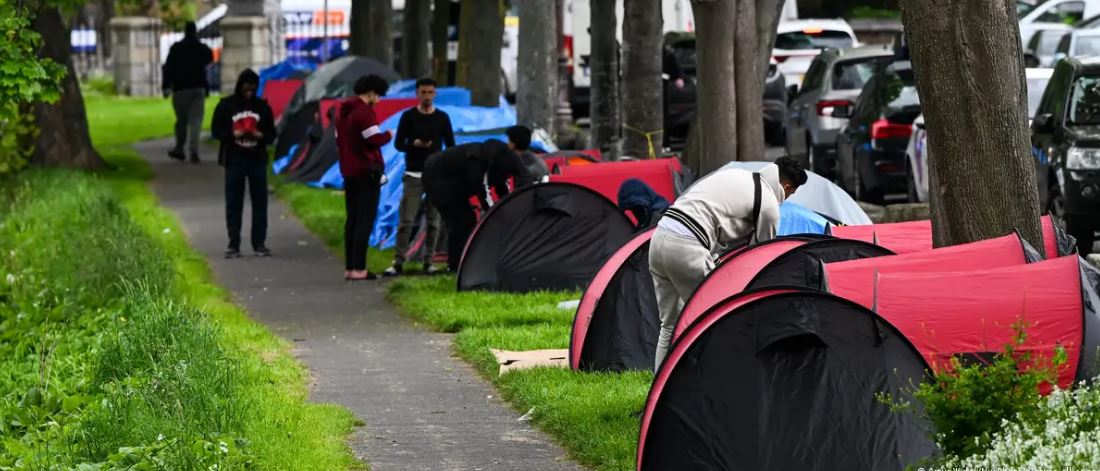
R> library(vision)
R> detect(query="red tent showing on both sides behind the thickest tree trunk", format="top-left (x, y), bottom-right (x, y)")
top-left (827, 215), bottom-right (1075, 259)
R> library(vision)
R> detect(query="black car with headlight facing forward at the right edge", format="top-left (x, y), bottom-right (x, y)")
top-left (1032, 58), bottom-right (1100, 254)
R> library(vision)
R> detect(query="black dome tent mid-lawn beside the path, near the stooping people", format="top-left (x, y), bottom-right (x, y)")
top-left (459, 183), bottom-right (634, 292)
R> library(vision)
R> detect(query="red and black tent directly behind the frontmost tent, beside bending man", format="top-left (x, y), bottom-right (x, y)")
top-left (672, 237), bottom-right (893, 340)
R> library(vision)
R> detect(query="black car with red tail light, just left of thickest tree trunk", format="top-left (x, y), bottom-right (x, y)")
top-left (833, 61), bottom-right (921, 204)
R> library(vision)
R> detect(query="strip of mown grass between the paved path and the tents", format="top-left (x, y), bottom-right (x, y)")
top-left (278, 168), bottom-right (652, 470)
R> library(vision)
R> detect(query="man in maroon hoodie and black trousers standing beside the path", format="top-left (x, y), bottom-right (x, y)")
top-left (336, 75), bottom-right (392, 281)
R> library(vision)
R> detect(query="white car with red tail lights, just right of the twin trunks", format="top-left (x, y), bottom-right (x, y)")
top-left (771, 19), bottom-right (858, 85)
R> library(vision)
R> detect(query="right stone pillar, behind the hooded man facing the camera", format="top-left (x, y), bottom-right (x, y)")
top-left (221, 17), bottom-right (272, 95)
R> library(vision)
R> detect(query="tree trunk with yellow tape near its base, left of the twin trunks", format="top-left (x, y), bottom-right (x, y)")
top-left (623, 0), bottom-right (664, 158)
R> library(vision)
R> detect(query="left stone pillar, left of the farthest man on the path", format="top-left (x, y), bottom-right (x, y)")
top-left (110, 17), bottom-right (163, 97)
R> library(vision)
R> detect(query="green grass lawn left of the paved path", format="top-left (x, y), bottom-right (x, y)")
top-left (0, 96), bottom-right (364, 470)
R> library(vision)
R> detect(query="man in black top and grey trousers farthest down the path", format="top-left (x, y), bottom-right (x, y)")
top-left (163, 21), bottom-right (213, 164)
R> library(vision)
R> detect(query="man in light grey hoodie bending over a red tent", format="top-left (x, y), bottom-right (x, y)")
top-left (649, 157), bottom-right (807, 370)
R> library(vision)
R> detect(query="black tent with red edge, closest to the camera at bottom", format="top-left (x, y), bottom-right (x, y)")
top-left (637, 289), bottom-right (936, 471)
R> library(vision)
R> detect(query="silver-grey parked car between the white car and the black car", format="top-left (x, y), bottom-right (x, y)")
top-left (785, 46), bottom-right (894, 177)
